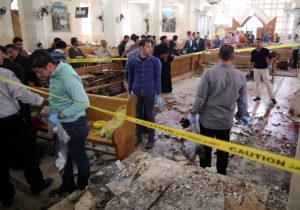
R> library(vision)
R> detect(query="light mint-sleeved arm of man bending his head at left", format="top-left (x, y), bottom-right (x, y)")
top-left (61, 75), bottom-right (90, 117)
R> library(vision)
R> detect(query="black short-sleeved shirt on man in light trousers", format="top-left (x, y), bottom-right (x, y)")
top-left (250, 48), bottom-right (272, 69)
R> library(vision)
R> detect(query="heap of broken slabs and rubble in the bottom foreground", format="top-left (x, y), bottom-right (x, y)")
top-left (51, 151), bottom-right (269, 210)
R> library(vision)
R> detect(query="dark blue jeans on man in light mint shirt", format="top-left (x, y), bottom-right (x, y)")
top-left (62, 116), bottom-right (90, 188)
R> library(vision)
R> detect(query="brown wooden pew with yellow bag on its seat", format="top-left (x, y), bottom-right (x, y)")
top-left (37, 88), bottom-right (136, 160)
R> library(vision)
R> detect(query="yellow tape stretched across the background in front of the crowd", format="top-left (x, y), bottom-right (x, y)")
top-left (67, 43), bottom-right (300, 63)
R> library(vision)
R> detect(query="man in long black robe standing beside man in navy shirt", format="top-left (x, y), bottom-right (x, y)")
top-left (154, 36), bottom-right (174, 93)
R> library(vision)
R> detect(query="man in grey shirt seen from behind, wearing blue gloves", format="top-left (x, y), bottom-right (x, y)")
top-left (181, 45), bottom-right (248, 175)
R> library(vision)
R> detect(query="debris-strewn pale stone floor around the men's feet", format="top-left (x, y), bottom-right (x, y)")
top-left (0, 75), bottom-right (300, 210)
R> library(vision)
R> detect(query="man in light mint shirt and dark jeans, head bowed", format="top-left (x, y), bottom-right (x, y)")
top-left (30, 50), bottom-right (90, 196)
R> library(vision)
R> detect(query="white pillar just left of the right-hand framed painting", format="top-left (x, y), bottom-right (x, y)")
top-left (149, 0), bottom-right (162, 36)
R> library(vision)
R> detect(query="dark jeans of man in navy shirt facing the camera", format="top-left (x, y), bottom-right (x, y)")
top-left (136, 95), bottom-right (155, 142)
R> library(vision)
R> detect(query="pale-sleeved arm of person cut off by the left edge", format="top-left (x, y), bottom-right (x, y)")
top-left (7, 72), bottom-right (44, 106)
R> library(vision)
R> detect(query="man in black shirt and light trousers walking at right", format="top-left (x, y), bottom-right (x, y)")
top-left (250, 39), bottom-right (277, 104)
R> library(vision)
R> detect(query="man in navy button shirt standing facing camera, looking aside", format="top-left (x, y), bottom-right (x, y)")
top-left (128, 39), bottom-right (163, 149)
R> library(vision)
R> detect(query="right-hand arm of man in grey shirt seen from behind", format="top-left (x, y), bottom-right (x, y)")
top-left (235, 76), bottom-right (248, 120)
